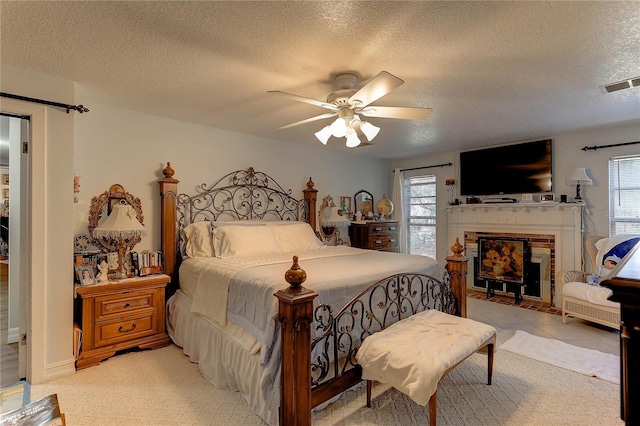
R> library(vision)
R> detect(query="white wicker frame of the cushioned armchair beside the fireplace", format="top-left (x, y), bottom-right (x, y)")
top-left (558, 235), bottom-right (620, 329)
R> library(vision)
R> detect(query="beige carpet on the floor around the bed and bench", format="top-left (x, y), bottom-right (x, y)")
top-left (31, 330), bottom-right (624, 426)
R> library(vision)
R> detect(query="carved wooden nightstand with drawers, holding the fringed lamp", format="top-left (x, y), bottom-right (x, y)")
top-left (75, 274), bottom-right (171, 370)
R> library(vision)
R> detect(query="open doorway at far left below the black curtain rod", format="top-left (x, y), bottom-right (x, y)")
top-left (0, 113), bottom-right (29, 388)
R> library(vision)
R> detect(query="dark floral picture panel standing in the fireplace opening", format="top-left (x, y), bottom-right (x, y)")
top-left (478, 237), bottom-right (528, 284)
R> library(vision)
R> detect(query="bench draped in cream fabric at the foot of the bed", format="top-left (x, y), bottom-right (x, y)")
top-left (356, 310), bottom-right (496, 426)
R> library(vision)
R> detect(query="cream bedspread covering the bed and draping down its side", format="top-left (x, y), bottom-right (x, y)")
top-left (179, 246), bottom-right (441, 406)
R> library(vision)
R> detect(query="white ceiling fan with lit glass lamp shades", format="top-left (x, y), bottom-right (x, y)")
top-left (268, 71), bottom-right (433, 148)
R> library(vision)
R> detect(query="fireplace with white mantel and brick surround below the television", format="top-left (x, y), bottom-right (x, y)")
top-left (447, 203), bottom-right (582, 307)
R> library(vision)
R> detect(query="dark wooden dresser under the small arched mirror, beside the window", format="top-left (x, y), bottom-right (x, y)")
top-left (349, 220), bottom-right (399, 253)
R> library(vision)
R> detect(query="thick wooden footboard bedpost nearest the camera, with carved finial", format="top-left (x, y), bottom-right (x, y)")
top-left (275, 256), bottom-right (318, 426)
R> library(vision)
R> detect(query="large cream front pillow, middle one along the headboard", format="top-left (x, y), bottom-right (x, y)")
top-left (213, 226), bottom-right (280, 259)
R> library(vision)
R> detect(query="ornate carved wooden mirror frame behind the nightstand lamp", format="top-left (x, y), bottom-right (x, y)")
top-left (88, 183), bottom-right (144, 253)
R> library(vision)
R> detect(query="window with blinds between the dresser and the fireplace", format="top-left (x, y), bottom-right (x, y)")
top-left (404, 176), bottom-right (436, 259)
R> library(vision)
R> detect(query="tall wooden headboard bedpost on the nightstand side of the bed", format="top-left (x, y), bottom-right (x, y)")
top-left (158, 163), bottom-right (180, 277)
